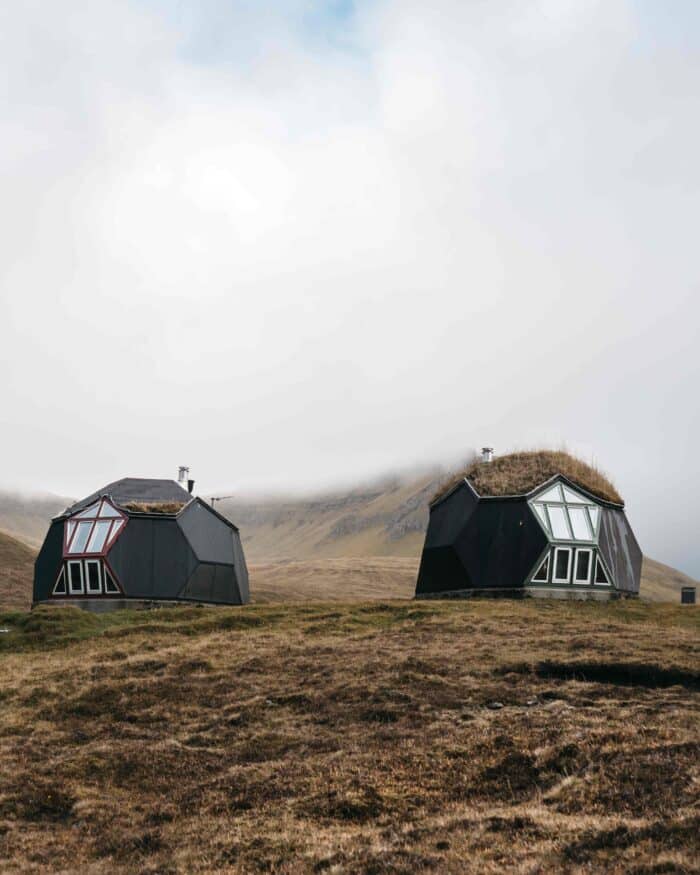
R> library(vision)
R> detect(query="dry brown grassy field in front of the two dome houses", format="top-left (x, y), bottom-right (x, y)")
top-left (0, 601), bottom-right (700, 875)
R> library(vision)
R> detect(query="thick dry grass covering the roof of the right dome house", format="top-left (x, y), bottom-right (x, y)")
top-left (433, 450), bottom-right (623, 504)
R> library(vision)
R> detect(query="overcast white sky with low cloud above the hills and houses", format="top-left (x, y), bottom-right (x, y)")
top-left (0, 0), bottom-right (700, 576)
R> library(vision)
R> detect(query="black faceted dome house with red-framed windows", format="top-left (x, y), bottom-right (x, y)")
top-left (34, 478), bottom-right (250, 610)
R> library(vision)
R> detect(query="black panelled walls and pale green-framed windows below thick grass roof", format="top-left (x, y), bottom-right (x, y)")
top-left (416, 476), bottom-right (642, 598)
